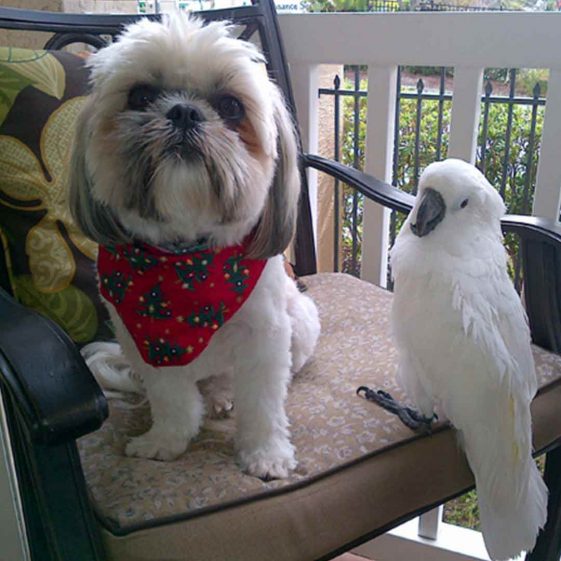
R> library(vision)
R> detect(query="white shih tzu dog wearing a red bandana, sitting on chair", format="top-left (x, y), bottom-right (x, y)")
top-left (70, 14), bottom-right (319, 478)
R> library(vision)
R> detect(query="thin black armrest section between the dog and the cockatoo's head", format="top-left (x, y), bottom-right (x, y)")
top-left (303, 154), bottom-right (415, 213)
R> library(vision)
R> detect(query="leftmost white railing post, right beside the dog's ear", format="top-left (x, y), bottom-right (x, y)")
top-left (290, 64), bottom-right (319, 245)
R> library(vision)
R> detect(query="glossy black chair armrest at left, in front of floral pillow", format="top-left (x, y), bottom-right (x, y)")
top-left (0, 289), bottom-right (108, 444)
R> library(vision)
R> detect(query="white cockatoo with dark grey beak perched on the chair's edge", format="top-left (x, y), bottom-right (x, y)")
top-left (391, 159), bottom-right (547, 560)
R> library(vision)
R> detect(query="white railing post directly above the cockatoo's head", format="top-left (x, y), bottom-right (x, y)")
top-left (448, 66), bottom-right (483, 164)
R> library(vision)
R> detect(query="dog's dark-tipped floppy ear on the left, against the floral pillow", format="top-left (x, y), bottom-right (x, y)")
top-left (69, 98), bottom-right (130, 245)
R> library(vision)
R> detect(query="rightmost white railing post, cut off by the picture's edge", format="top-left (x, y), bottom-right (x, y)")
top-left (532, 70), bottom-right (561, 220)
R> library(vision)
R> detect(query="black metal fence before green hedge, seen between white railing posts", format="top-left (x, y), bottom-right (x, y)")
top-left (319, 66), bottom-right (545, 287)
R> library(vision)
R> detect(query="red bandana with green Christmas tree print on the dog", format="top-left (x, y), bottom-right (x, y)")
top-left (97, 240), bottom-right (267, 366)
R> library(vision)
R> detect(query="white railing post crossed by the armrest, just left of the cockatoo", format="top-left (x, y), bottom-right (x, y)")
top-left (361, 65), bottom-right (397, 286)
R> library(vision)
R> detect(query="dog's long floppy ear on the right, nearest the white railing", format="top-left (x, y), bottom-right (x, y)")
top-left (249, 88), bottom-right (300, 259)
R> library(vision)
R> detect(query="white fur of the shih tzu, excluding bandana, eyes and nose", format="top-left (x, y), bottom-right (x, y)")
top-left (71, 15), bottom-right (320, 478)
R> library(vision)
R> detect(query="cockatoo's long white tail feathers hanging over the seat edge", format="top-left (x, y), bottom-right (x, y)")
top-left (461, 394), bottom-right (547, 561)
